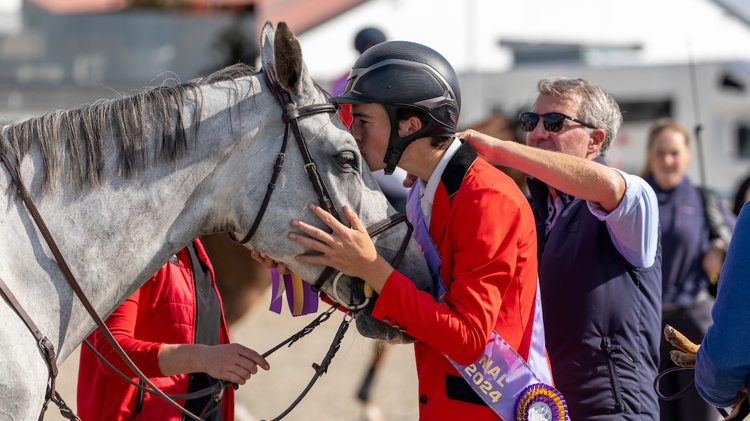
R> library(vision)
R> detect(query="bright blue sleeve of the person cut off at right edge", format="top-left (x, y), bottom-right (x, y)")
top-left (695, 205), bottom-right (750, 407)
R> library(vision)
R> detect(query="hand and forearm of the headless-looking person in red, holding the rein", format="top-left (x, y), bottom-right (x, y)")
top-left (159, 344), bottom-right (271, 384)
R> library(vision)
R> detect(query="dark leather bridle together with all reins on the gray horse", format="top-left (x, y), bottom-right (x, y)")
top-left (0, 62), bottom-right (412, 421)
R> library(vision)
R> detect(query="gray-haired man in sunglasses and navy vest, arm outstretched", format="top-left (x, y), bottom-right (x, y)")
top-left (462, 78), bottom-right (661, 421)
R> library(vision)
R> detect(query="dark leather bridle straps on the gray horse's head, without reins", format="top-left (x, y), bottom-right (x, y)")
top-left (228, 61), bottom-right (413, 311)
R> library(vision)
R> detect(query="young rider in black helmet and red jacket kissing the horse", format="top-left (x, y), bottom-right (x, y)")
top-left (254, 41), bottom-right (567, 421)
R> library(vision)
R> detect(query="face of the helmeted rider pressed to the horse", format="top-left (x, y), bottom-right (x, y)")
top-left (349, 104), bottom-right (391, 171)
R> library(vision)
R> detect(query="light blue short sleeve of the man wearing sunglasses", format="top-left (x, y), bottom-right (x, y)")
top-left (586, 168), bottom-right (659, 268)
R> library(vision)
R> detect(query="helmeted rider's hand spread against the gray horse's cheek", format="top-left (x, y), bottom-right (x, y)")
top-left (289, 204), bottom-right (393, 292)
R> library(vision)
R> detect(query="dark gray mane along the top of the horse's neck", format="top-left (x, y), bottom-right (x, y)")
top-left (0, 63), bottom-right (257, 192)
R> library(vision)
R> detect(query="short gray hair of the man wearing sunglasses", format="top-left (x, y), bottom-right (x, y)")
top-left (537, 77), bottom-right (622, 156)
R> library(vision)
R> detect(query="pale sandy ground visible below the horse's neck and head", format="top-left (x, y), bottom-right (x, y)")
top-left (44, 298), bottom-right (418, 421)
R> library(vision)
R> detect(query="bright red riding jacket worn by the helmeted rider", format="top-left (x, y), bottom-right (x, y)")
top-left (372, 159), bottom-right (537, 420)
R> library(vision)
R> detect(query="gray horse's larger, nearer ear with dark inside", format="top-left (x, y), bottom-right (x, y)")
top-left (274, 22), bottom-right (309, 95)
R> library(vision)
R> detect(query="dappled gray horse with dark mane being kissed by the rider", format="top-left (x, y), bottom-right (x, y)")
top-left (0, 23), bottom-right (431, 421)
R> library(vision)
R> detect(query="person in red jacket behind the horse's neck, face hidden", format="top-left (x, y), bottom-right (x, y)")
top-left (77, 239), bottom-right (270, 421)
